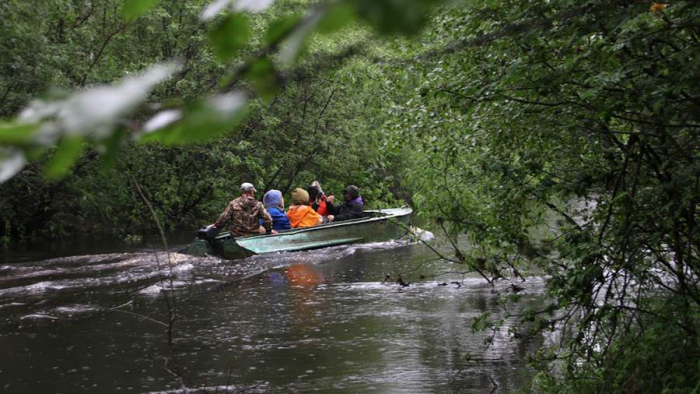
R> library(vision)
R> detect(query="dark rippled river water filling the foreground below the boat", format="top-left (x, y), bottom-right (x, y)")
top-left (0, 235), bottom-right (543, 393)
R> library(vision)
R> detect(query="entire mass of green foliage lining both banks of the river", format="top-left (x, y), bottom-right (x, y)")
top-left (0, 0), bottom-right (700, 392)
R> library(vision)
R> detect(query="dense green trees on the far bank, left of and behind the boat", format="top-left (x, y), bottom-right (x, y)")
top-left (0, 1), bottom-right (402, 242)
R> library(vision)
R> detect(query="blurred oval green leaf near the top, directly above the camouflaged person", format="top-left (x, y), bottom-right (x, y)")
top-left (209, 14), bottom-right (250, 62)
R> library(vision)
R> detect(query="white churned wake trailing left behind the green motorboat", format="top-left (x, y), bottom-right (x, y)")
top-left (0, 240), bottom-right (411, 326)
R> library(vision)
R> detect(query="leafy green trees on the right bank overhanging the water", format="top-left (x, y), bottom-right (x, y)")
top-left (389, 1), bottom-right (700, 392)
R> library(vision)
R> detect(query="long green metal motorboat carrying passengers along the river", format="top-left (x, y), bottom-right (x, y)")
top-left (182, 208), bottom-right (413, 260)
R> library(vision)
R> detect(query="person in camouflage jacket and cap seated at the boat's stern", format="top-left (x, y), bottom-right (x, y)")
top-left (214, 182), bottom-right (277, 237)
